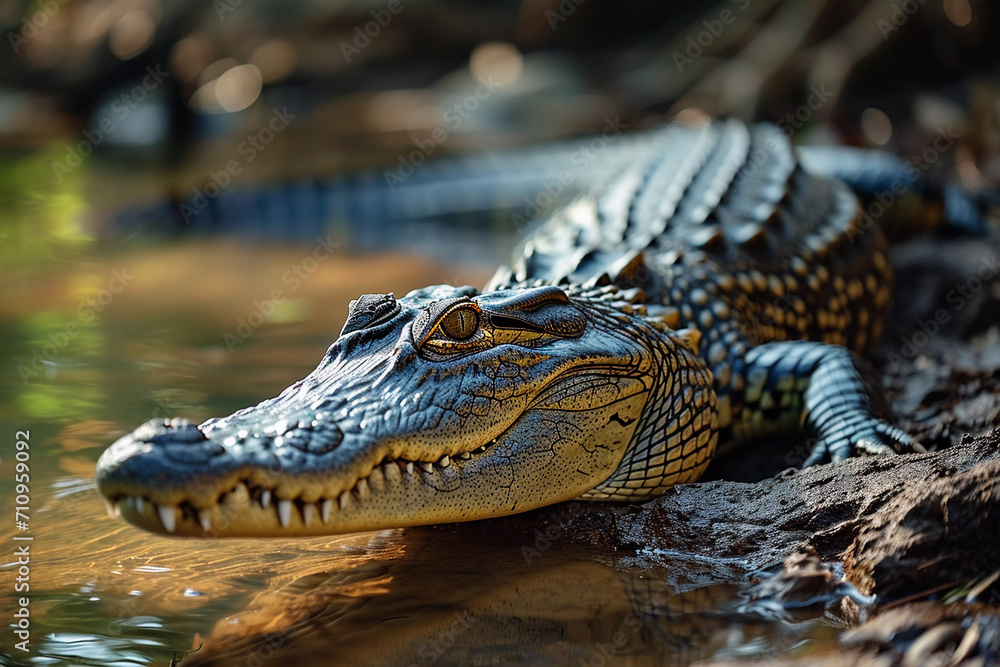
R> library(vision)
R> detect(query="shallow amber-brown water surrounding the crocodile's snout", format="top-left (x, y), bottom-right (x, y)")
top-left (0, 155), bottom-right (835, 667)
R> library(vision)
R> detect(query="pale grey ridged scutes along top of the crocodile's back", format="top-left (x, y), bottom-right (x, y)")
top-left (487, 121), bottom-right (856, 318)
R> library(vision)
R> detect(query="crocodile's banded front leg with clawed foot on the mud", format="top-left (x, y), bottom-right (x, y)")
top-left (728, 341), bottom-right (925, 467)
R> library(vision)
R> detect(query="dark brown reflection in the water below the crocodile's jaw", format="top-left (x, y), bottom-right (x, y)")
top-left (183, 529), bottom-right (836, 665)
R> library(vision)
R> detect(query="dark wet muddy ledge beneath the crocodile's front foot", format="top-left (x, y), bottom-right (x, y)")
top-left (456, 429), bottom-right (1000, 598)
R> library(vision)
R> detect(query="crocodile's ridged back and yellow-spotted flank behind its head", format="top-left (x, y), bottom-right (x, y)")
top-left (487, 121), bottom-right (892, 360)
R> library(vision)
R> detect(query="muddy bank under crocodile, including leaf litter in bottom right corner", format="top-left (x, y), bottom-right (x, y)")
top-left (449, 429), bottom-right (1000, 666)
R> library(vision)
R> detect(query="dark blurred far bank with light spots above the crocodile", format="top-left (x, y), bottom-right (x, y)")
top-left (0, 0), bottom-right (1000, 250)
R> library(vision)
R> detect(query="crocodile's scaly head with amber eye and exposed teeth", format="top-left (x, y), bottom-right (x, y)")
top-left (97, 286), bottom-right (716, 536)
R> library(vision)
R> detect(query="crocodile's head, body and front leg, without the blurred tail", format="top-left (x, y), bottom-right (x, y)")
top-left (96, 120), bottom-right (988, 537)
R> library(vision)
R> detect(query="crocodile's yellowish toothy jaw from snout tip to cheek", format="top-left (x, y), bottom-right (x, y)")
top-left (98, 382), bottom-right (646, 537)
